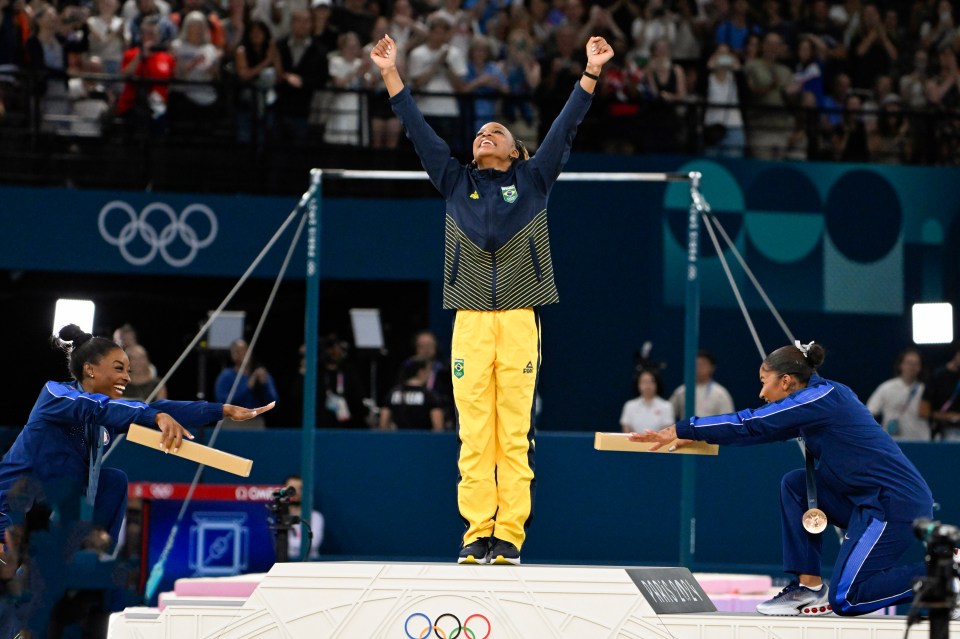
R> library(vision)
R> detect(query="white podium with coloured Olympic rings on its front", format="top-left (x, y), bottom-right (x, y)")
top-left (108, 562), bottom-right (960, 639)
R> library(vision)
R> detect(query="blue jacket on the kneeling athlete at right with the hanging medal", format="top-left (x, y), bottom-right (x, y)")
top-left (677, 374), bottom-right (933, 521)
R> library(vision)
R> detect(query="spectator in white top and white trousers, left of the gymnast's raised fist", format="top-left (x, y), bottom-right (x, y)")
top-left (323, 31), bottom-right (370, 146)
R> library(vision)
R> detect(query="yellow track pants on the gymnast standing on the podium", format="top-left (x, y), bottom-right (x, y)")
top-left (450, 308), bottom-right (540, 548)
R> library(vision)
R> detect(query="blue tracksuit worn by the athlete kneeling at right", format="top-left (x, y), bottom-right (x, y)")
top-left (677, 375), bottom-right (933, 615)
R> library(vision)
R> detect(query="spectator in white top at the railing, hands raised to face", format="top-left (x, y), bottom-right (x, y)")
top-left (703, 44), bottom-right (746, 157)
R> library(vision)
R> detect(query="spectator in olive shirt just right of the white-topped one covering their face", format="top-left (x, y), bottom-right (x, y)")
top-left (744, 33), bottom-right (793, 160)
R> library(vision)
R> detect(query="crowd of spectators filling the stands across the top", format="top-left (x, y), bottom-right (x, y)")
top-left (0, 0), bottom-right (960, 164)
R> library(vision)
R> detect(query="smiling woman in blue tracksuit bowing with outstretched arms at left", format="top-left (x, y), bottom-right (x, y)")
top-left (0, 324), bottom-right (271, 543)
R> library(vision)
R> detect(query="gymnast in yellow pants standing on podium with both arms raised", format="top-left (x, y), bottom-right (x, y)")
top-left (370, 31), bottom-right (613, 564)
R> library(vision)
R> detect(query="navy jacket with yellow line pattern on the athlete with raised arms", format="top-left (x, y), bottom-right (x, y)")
top-left (390, 83), bottom-right (593, 311)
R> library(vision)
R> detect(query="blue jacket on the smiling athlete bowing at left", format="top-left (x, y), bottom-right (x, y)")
top-left (0, 381), bottom-right (223, 504)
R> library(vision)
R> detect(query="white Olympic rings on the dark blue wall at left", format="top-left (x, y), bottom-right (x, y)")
top-left (97, 200), bottom-right (217, 268)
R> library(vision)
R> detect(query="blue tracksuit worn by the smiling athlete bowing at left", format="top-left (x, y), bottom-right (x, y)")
top-left (0, 381), bottom-right (223, 540)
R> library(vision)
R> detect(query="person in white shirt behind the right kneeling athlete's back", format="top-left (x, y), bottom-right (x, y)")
top-left (867, 347), bottom-right (930, 441)
